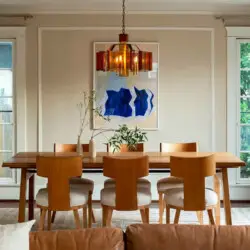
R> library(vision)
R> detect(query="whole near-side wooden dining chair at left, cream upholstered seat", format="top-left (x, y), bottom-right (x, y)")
top-left (36, 156), bottom-right (91, 230)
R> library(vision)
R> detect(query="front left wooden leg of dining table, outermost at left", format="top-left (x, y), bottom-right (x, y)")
top-left (18, 168), bottom-right (27, 222)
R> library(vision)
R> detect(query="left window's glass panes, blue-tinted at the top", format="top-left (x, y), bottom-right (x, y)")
top-left (0, 40), bottom-right (15, 178)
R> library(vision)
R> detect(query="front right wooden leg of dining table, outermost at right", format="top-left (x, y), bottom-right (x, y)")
top-left (222, 168), bottom-right (232, 225)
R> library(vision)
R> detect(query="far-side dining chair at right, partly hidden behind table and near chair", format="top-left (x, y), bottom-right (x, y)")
top-left (157, 142), bottom-right (198, 224)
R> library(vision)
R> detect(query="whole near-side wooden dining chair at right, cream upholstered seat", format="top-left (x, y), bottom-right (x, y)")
top-left (164, 155), bottom-right (218, 225)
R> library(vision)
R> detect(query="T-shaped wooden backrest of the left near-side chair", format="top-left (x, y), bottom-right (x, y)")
top-left (36, 156), bottom-right (82, 211)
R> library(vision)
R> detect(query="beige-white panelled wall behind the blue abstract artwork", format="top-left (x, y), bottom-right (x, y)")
top-left (0, 15), bottom-right (229, 198)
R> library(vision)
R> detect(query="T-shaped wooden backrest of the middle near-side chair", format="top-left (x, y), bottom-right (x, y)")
top-left (103, 156), bottom-right (149, 211)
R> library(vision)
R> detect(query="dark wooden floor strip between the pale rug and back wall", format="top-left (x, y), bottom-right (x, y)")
top-left (0, 200), bottom-right (250, 208)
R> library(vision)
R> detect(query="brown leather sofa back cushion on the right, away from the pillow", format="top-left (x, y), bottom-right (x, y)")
top-left (126, 224), bottom-right (250, 250)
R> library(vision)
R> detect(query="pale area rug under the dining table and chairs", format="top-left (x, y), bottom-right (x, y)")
top-left (0, 207), bottom-right (250, 231)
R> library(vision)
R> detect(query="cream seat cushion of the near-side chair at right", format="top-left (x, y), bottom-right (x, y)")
top-left (164, 188), bottom-right (218, 208)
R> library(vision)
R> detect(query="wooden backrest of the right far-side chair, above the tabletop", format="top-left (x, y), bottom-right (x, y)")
top-left (160, 142), bottom-right (198, 153)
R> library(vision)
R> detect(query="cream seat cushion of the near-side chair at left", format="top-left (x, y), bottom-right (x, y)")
top-left (36, 185), bottom-right (89, 207)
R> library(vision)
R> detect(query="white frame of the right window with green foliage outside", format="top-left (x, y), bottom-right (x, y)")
top-left (226, 27), bottom-right (250, 186)
